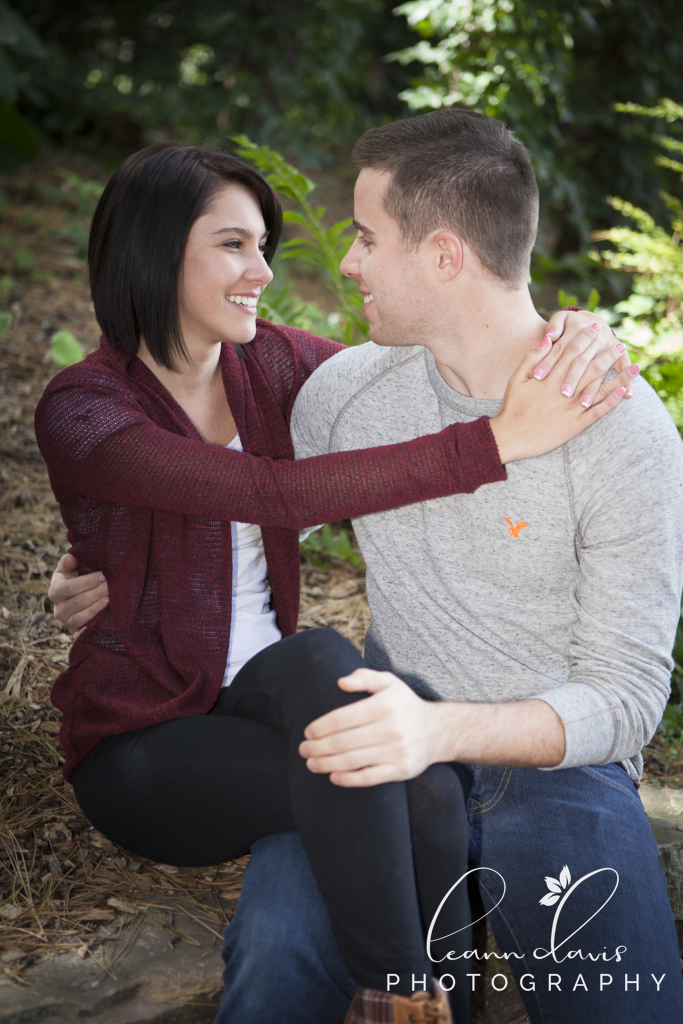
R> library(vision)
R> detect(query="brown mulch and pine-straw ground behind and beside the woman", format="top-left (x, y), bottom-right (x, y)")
top-left (0, 158), bottom-right (369, 984)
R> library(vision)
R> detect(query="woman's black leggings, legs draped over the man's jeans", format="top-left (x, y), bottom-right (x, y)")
top-left (74, 630), bottom-right (471, 1003)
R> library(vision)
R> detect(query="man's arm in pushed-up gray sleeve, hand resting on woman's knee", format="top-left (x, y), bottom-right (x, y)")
top-left (301, 384), bottom-right (683, 785)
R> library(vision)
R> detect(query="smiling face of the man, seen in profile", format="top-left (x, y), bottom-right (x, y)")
top-left (341, 169), bottom-right (436, 345)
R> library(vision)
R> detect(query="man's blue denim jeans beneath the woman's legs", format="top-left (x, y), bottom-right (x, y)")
top-left (216, 765), bottom-right (683, 1024)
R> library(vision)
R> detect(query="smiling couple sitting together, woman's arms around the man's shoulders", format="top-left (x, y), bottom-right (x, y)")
top-left (41, 110), bottom-right (683, 1024)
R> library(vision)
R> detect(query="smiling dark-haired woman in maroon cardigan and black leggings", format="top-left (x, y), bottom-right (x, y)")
top-left (36, 146), bottom-right (632, 1020)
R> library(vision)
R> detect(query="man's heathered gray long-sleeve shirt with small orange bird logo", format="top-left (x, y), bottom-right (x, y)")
top-left (292, 342), bottom-right (683, 777)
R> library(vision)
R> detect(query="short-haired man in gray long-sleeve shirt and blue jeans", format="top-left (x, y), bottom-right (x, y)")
top-left (49, 111), bottom-right (683, 1024)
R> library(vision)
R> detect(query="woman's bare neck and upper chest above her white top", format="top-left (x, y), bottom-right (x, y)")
top-left (137, 340), bottom-right (238, 444)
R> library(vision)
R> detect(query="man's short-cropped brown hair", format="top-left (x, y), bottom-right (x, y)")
top-left (353, 109), bottom-right (539, 287)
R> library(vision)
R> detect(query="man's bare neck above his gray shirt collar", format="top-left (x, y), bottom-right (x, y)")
top-left (425, 288), bottom-right (546, 398)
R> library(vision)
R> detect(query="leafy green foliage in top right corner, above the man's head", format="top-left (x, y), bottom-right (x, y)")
top-left (393, 0), bottom-right (683, 245)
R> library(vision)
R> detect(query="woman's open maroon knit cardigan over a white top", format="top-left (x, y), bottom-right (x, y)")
top-left (36, 321), bottom-right (505, 779)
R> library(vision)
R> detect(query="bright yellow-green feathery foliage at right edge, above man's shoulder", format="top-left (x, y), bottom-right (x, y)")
top-left (593, 99), bottom-right (683, 431)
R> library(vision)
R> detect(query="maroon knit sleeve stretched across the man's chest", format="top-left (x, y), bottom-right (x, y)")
top-left (36, 383), bottom-right (506, 529)
